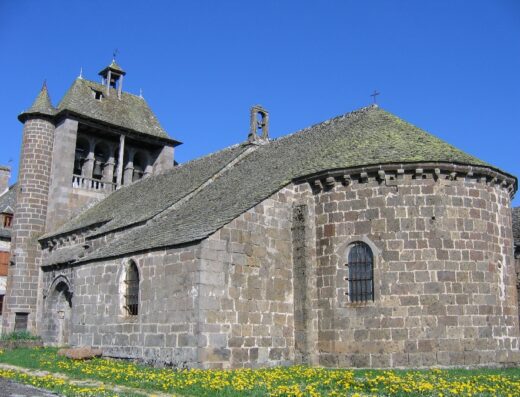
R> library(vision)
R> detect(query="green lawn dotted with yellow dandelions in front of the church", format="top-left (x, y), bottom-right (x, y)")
top-left (0, 348), bottom-right (520, 397)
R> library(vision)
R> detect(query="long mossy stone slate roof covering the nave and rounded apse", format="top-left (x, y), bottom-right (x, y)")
top-left (43, 107), bottom-right (512, 260)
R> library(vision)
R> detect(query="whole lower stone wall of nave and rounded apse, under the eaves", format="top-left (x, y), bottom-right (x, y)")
top-left (38, 165), bottom-right (520, 368)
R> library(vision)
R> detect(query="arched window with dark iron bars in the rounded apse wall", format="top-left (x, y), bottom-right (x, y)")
top-left (347, 241), bottom-right (374, 302)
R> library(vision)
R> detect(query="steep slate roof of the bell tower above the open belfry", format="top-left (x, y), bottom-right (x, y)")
top-left (58, 78), bottom-right (178, 144)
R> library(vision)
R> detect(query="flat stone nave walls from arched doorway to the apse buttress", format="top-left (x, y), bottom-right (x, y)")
top-left (41, 188), bottom-right (294, 368)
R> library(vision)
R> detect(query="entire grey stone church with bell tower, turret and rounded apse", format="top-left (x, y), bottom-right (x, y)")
top-left (3, 61), bottom-right (520, 368)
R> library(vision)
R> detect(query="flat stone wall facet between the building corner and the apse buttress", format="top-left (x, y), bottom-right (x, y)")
top-left (199, 188), bottom-right (294, 368)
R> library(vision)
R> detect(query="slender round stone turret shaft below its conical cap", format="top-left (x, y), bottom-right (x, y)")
top-left (3, 118), bottom-right (54, 331)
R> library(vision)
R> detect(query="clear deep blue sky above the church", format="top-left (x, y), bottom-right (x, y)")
top-left (0, 0), bottom-right (520, 205)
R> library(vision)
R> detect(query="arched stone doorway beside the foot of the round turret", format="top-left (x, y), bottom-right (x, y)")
top-left (45, 280), bottom-right (72, 346)
